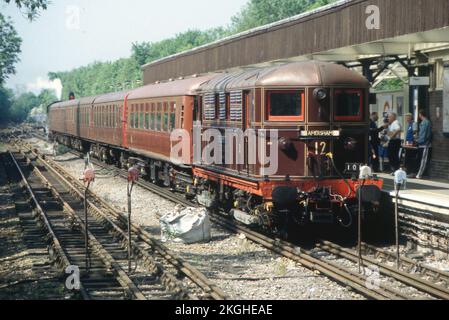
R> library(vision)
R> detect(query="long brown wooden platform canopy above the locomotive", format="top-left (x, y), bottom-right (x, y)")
top-left (142, 0), bottom-right (449, 84)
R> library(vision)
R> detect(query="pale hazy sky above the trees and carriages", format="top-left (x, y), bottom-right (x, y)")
top-left (0, 0), bottom-right (247, 94)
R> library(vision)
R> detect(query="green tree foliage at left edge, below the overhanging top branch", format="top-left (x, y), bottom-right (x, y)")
top-left (0, 14), bottom-right (22, 85)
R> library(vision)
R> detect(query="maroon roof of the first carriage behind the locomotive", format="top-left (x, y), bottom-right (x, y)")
top-left (128, 74), bottom-right (217, 100)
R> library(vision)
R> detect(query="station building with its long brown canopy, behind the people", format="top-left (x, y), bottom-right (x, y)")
top-left (142, 0), bottom-right (449, 180)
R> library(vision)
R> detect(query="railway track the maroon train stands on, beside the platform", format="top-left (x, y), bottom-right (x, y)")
top-left (13, 138), bottom-right (449, 300)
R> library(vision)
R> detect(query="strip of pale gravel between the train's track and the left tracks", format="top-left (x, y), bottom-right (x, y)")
top-left (20, 139), bottom-right (372, 300)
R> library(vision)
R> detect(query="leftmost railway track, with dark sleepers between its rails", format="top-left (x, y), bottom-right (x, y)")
top-left (4, 153), bottom-right (144, 299)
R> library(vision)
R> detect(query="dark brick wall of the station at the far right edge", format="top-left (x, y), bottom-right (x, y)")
top-left (429, 90), bottom-right (449, 180)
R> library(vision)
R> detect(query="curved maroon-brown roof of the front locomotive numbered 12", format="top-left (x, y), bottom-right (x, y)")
top-left (196, 61), bottom-right (370, 92)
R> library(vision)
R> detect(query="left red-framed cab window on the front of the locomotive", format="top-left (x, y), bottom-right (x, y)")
top-left (267, 90), bottom-right (305, 121)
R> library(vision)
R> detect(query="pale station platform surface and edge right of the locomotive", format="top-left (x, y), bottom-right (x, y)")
top-left (378, 174), bottom-right (449, 220)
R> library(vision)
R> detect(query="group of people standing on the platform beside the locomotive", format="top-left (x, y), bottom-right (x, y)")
top-left (370, 110), bottom-right (432, 179)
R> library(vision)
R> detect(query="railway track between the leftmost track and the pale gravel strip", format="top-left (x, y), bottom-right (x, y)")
top-left (14, 141), bottom-right (227, 300)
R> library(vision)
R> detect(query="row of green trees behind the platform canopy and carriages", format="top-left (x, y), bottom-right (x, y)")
top-left (49, 0), bottom-right (336, 100)
